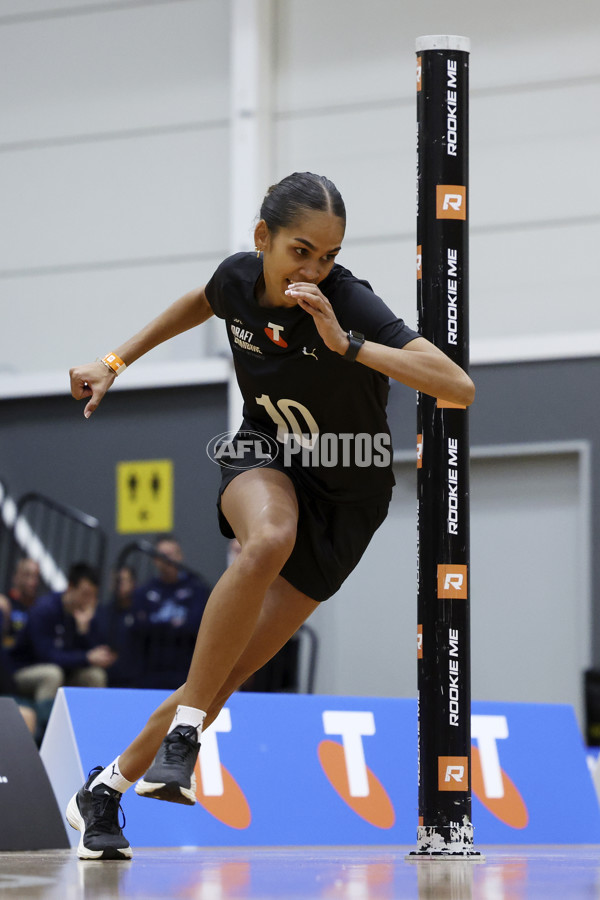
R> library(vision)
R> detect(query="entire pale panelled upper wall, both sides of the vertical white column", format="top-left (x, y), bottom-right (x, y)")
top-left (0, 0), bottom-right (600, 380)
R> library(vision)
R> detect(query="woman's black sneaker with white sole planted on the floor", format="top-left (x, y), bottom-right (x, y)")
top-left (67, 766), bottom-right (132, 859)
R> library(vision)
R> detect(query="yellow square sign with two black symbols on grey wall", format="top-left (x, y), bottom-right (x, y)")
top-left (117, 459), bottom-right (173, 534)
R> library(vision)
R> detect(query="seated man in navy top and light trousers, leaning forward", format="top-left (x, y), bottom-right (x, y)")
top-left (11, 563), bottom-right (116, 702)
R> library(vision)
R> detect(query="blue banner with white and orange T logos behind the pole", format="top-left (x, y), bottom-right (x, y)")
top-left (42, 688), bottom-right (600, 847)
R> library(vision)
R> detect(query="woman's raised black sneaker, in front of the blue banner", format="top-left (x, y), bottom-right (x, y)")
top-left (135, 725), bottom-right (200, 806)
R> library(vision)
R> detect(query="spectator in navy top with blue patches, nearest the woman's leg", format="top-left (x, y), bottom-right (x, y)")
top-left (133, 535), bottom-right (209, 689)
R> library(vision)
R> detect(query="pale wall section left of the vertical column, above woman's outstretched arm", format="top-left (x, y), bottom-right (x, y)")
top-left (0, 0), bottom-right (229, 372)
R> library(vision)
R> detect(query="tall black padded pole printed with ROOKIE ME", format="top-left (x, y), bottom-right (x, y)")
top-left (411, 35), bottom-right (481, 859)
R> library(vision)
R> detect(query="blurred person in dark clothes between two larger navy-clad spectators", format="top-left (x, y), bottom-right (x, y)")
top-left (96, 566), bottom-right (142, 687)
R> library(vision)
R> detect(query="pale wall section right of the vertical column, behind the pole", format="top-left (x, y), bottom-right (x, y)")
top-left (276, 0), bottom-right (600, 361)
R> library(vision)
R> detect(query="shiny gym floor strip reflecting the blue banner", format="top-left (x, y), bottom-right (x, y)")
top-left (0, 845), bottom-right (600, 900)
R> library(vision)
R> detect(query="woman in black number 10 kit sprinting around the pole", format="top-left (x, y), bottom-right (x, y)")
top-left (67, 172), bottom-right (474, 859)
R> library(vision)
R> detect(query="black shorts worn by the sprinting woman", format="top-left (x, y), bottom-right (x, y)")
top-left (217, 460), bottom-right (390, 602)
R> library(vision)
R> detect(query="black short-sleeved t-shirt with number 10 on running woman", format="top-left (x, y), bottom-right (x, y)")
top-left (206, 253), bottom-right (419, 503)
